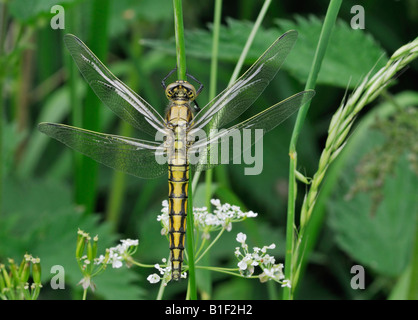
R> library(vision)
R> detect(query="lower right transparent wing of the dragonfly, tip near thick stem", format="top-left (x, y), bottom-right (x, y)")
top-left (188, 90), bottom-right (315, 171)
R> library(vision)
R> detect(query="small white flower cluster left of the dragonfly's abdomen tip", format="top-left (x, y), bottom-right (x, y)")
top-left (94, 239), bottom-right (138, 269)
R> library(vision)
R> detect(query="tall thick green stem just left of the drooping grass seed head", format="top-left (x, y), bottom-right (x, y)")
top-left (283, 0), bottom-right (342, 300)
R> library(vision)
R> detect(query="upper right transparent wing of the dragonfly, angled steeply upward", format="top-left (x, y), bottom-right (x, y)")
top-left (191, 30), bottom-right (298, 132)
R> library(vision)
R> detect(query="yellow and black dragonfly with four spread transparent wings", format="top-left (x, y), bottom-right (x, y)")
top-left (38, 30), bottom-right (315, 280)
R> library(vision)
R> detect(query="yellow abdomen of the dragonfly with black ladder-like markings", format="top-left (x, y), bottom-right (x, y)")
top-left (168, 164), bottom-right (189, 280)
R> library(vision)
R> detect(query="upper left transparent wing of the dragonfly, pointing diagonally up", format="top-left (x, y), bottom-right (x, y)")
top-left (64, 34), bottom-right (164, 136)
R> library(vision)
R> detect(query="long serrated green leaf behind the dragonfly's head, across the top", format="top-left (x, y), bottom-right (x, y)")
top-left (142, 16), bottom-right (387, 88)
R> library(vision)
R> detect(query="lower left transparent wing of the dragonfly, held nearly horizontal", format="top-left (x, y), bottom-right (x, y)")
top-left (38, 122), bottom-right (167, 178)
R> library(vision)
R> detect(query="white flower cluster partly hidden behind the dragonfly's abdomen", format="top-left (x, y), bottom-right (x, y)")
top-left (157, 199), bottom-right (257, 237)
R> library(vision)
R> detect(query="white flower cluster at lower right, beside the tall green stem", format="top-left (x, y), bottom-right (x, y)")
top-left (235, 232), bottom-right (290, 287)
